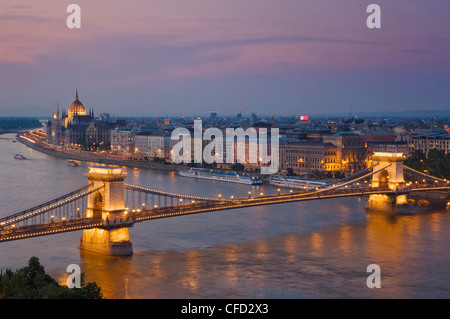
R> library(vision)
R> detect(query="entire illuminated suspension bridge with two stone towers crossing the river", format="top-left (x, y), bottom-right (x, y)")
top-left (0, 153), bottom-right (450, 256)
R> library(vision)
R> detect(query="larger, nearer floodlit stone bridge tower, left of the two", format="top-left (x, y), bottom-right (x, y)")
top-left (80, 166), bottom-right (133, 256)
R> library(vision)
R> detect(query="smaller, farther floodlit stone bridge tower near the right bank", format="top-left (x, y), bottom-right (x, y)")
top-left (366, 152), bottom-right (407, 212)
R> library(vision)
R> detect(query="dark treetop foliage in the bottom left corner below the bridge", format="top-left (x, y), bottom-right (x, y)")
top-left (0, 257), bottom-right (102, 299)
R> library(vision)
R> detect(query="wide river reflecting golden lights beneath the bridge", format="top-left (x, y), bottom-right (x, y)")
top-left (0, 134), bottom-right (450, 299)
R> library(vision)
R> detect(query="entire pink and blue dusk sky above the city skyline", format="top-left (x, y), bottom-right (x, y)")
top-left (0, 0), bottom-right (450, 116)
